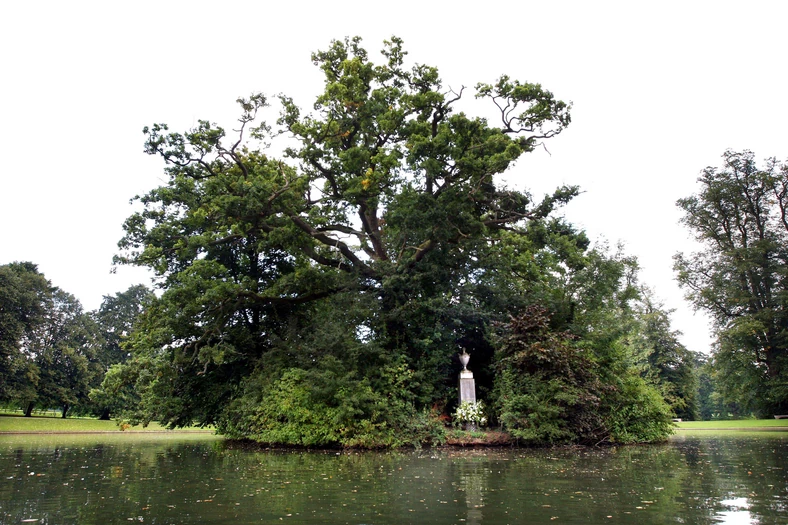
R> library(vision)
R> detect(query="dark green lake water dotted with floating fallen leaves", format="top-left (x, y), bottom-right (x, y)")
top-left (0, 432), bottom-right (788, 525)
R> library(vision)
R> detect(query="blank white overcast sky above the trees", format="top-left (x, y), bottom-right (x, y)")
top-left (0, 0), bottom-right (788, 351)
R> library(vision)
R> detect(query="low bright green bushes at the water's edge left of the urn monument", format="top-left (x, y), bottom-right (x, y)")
top-left (218, 352), bottom-right (445, 448)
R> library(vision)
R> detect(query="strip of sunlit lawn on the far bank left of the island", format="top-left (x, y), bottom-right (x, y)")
top-left (0, 414), bottom-right (213, 433)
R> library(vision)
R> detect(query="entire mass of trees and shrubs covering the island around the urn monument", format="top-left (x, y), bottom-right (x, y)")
top-left (106, 38), bottom-right (688, 447)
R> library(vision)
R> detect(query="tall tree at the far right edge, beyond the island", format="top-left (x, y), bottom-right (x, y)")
top-left (675, 151), bottom-right (788, 416)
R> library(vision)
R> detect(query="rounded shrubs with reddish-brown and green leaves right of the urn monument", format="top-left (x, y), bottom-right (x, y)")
top-left (496, 306), bottom-right (671, 445)
